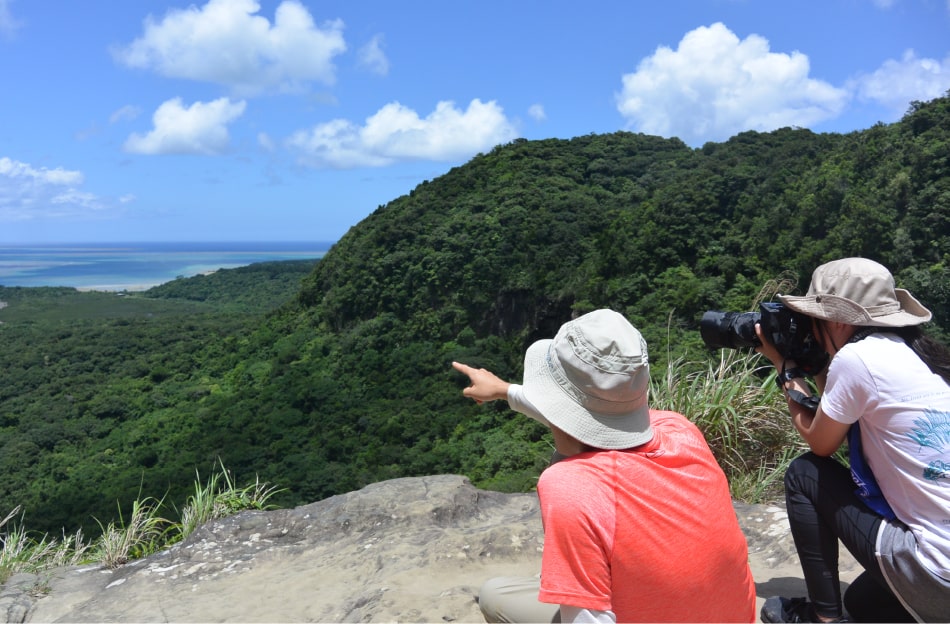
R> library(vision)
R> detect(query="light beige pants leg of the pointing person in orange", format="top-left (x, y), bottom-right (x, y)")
top-left (478, 576), bottom-right (561, 622)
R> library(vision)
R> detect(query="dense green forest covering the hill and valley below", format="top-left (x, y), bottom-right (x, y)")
top-left (0, 94), bottom-right (950, 532)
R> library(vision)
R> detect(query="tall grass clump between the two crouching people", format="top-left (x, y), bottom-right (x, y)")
top-left (650, 349), bottom-right (805, 503)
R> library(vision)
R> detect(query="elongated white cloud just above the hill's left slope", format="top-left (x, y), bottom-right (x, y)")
top-left (287, 99), bottom-right (518, 168)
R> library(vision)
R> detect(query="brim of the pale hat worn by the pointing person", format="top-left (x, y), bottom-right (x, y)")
top-left (522, 340), bottom-right (653, 449)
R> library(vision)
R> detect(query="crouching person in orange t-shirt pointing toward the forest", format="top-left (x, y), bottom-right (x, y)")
top-left (453, 310), bottom-right (756, 622)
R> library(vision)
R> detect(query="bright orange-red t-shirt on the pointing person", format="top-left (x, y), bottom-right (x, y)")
top-left (538, 410), bottom-right (756, 622)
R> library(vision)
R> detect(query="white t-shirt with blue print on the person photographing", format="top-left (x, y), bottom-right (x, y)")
top-left (821, 333), bottom-right (950, 580)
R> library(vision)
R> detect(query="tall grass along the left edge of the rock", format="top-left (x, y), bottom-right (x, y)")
top-left (0, 461), bottom-right (279, 585)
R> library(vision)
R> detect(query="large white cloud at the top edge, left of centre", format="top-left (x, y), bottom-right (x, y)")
top-left (113, 0), bottom-right (346, 95)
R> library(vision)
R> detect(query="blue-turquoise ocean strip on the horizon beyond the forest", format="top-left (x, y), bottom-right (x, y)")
top-left (0, 242), bottom-right (333, 291)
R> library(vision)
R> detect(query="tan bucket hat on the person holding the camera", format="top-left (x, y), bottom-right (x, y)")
top-left (778, 258), bottom-right (932, 327)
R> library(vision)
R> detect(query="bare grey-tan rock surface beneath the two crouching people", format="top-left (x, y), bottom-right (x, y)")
top-left (0, 475), bottom-right (860, 622)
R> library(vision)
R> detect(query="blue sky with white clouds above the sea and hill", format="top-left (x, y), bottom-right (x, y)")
top-left (0, 0), bottom-right (950, 244)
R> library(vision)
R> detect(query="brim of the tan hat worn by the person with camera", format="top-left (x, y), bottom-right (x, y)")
top-left (778, 288), bottom-right (932, 327)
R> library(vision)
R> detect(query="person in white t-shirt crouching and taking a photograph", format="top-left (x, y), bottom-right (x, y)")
top-left (755, 258), bottom-right (950, 622)
